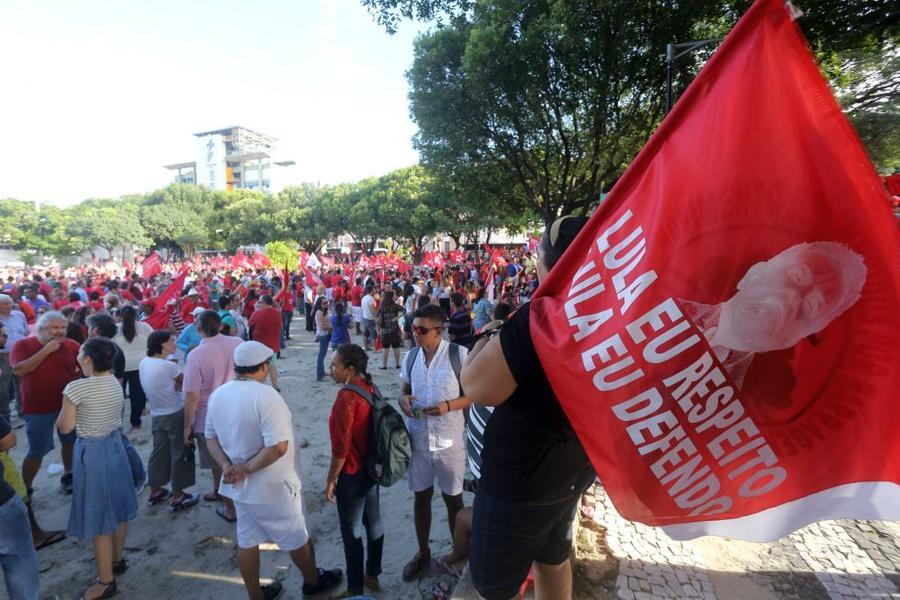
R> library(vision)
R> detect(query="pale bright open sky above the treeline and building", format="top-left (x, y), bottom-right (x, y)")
top-left (0, 0), bottom-right (418, 205)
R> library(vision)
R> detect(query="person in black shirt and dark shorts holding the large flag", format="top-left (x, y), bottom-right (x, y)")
top-left (462, 216), bottom-right (595, 598)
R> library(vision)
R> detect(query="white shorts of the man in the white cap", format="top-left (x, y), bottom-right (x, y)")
top-left (234, 487), bottom-right (309, 552)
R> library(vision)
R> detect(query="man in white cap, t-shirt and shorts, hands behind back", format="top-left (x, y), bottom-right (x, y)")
top-left (205, 341), bottom-right (342, 600)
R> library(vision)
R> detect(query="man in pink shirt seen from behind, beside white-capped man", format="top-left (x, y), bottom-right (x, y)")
top-left (181, 310), bottom-right (241, 523)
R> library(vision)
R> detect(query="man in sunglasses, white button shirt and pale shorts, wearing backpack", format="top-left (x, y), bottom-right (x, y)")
top-left (399, 304), bottom-right (471, 581)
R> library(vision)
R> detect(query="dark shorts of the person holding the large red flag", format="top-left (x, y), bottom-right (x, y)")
top-left (469, 491), bottom-right (578, 600)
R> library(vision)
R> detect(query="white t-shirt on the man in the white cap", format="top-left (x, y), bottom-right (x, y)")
top-left (205, 379), bottom-right (300, 504)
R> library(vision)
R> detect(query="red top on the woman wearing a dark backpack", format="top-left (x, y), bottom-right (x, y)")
top-left (328, 377), bottom-right (373, 475)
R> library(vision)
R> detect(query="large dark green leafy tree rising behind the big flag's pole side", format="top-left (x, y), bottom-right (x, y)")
top-left (408, 0), bottom-right (724, 224)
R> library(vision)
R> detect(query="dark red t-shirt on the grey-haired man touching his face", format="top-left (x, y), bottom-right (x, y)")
top-left (9, 337), bottom-right (81, 415)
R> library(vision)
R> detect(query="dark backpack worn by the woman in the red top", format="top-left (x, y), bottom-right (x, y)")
top-left (344, 384), bottom-right (412, 487)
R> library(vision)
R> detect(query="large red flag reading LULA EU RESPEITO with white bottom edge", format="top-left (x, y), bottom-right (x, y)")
top-left (531, 0), bottom-right (900, 541)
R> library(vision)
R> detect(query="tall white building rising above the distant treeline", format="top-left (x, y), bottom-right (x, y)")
top-left (166, 127), bottom-right (296, 193)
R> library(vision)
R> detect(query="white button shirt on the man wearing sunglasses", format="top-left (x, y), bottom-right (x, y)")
top-left (400, 340), bottom-right (468, 452)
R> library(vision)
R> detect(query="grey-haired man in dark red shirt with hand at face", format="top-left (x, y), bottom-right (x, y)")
top-left (9, 311), bottom-right (80, 494)
